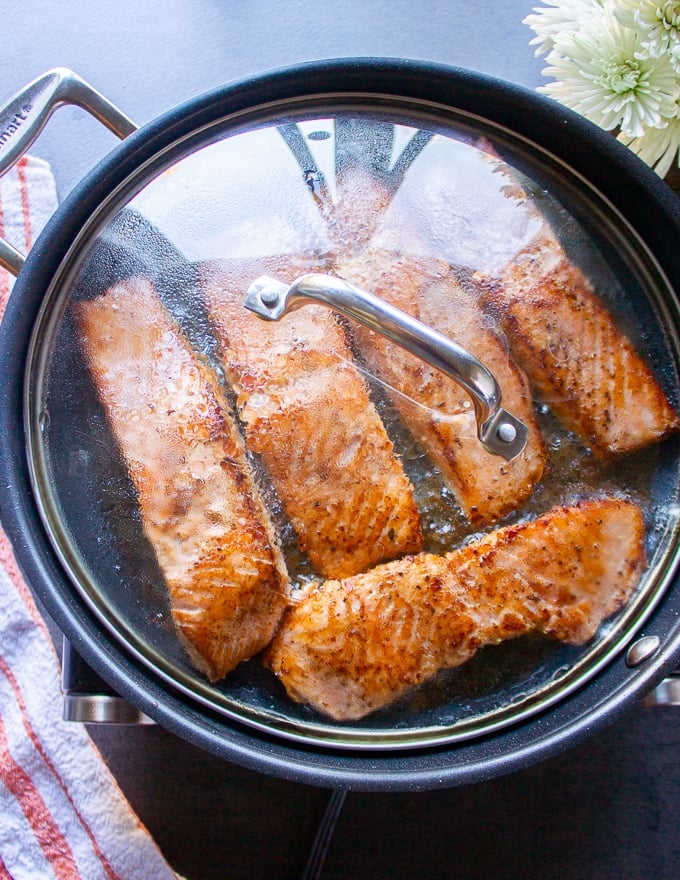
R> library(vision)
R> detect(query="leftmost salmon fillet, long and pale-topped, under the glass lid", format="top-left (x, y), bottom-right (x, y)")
top-left (77, 278), bottom-right (287, 681)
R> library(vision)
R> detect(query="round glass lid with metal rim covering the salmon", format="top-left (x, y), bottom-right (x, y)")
top-left (26, 96), bottom-right (680, 749)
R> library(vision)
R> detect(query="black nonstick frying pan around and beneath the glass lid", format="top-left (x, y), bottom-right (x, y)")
top-left (0, 60), bottom-right (680, 789)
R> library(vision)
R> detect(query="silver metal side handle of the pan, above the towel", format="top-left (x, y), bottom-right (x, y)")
top-left (0, 67), bottom-right (137, 275)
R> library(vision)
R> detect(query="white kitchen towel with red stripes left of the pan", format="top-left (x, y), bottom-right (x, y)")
top-left (0, 157), bottom-right (181, 880)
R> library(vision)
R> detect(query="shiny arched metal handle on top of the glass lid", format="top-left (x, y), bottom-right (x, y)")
top-left (244, 274), bottom-right (529, 461)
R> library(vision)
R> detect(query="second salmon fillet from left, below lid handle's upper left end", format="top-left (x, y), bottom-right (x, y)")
top-left (204, 264), bottom-right (422, 577)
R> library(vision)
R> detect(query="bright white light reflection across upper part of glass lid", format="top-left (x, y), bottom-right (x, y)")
top-left (130, 117), bottom-right (538, 273)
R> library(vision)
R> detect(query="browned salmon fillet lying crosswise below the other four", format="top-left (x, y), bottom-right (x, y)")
top-left (267, 499), bottom-right (645, 721)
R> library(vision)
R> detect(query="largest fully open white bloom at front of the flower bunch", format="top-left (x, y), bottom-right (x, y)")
top-left (539, 3), bottom-right (678, 138)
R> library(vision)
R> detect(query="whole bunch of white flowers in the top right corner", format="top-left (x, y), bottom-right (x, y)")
top-left (524, 0), bottom-right (680, 177)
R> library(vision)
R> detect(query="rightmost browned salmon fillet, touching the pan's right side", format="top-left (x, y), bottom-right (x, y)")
top-left (487, 230), bottom-right (680, 459)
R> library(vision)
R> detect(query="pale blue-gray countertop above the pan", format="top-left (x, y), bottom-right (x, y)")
top-left (2, 0), bottom-right (542, 194)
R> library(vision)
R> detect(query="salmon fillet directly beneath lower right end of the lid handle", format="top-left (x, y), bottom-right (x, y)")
top-left (336, 250), bottom-right (546, 523)
